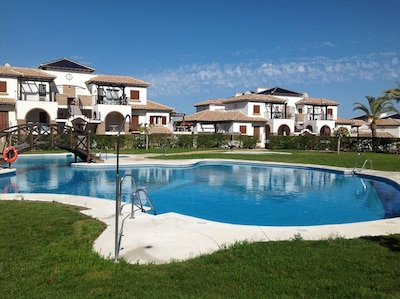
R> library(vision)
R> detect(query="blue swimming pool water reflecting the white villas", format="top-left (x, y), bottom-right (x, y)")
top-left (0, 155), bottom-right (400, 226)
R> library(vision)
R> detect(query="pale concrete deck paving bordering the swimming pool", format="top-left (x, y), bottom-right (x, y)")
top-left (1, 155), bottom-right (400, 264)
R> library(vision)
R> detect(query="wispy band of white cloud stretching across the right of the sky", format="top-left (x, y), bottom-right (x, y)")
top-left (141, 52), bottom-right (400, 96)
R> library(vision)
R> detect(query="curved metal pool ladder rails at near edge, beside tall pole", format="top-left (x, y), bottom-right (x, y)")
top-left (117, 174), bottom-right (157, 253)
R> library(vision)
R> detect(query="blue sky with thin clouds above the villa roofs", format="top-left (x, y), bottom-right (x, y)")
top-left (0, 0), bottom-right (400, 118)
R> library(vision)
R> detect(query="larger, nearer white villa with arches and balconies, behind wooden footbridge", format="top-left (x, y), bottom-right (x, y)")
top-left (0, 58), bottom-right (174, 135)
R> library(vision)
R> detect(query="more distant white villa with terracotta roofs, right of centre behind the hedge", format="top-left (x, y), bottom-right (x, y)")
top-left (179, 87), bottom-right (339, 146)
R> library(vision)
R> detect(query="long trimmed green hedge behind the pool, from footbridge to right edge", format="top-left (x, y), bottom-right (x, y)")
top-left (91, 134), bottom-right (400, 153)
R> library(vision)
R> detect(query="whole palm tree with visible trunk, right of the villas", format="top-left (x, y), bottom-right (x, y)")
top-left (353, 96), bottom-right (397, 137)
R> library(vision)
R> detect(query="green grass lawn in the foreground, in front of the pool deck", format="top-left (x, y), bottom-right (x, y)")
top-left (0, 201), bottom-right (400, 298)
